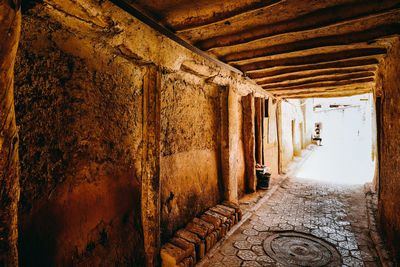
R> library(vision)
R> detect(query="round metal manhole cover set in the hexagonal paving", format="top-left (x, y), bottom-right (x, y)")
top-left (263, 231), bottom-right (341, 267)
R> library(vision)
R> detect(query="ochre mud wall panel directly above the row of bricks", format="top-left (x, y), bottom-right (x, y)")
top-left (160, 74), bottom-right (222, 242)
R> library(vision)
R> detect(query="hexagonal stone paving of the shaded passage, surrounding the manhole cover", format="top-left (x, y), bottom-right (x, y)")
top-left (202, 179), bottom-right (380, 267)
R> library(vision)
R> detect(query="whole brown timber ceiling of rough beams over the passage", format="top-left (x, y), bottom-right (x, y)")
top-left (119, 0), bottom-right (400, 98)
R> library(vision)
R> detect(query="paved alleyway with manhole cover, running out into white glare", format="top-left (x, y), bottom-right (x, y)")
top-left (203, 100), bottom-right (381, 267)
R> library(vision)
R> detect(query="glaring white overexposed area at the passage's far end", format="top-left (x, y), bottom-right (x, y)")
top-left (295, 97), bottom-right (375, 184)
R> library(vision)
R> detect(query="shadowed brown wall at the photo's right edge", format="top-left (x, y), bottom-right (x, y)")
top-left (378, 37), bottom-right (400, 264)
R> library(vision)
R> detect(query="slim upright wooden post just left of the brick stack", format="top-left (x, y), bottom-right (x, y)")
top-left (141, 65), bottom-right (161, 266)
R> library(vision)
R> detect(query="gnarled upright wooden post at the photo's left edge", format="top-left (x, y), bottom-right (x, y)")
top-left (0, 0), bottom-right (21, 267)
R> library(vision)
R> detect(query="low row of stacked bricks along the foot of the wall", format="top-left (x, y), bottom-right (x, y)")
top-left (161, 201), bottom-right (242, 267)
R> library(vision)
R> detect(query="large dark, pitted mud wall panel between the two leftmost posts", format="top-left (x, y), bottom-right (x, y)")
top-left (15, 10), bottom-right (143, 266)
